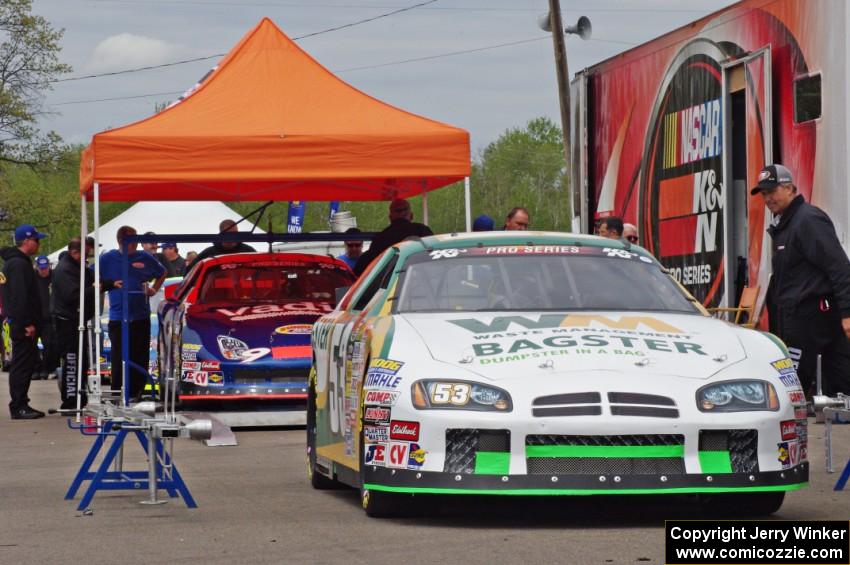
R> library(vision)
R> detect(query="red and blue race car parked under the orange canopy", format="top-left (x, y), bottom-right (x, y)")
top-left (158, 253), bottom-right (354, 409)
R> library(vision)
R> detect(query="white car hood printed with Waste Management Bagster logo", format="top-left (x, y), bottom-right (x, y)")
top-left (396, 312), bottom-right (746, 380)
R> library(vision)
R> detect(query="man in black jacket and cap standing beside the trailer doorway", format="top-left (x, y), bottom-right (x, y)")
top-left (751, 165), bottom-right (850, 395)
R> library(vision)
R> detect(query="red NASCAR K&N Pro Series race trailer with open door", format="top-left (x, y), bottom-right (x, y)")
top-left (570, 0), bottom-right (850, 323)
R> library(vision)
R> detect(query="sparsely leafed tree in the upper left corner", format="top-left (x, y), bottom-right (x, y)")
top-left (0, 0), bottom-right (71, 165)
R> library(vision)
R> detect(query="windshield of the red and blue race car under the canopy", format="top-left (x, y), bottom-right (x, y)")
top-left (198, 262), bottom-right (353, 304)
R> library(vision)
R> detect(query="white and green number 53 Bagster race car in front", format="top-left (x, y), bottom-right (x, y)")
top-left (307, 232), bottom-right (808, 515)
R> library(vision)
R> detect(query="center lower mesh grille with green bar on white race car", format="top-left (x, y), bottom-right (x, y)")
top-left (525, 434), bottom-right (685, 475)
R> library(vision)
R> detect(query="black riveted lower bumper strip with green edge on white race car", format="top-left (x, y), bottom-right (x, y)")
top-left (364, 462), bottom-right (809, 495)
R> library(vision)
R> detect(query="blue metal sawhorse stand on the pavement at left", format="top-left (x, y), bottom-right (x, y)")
top-left (65, 422), bottom-right (198, 510)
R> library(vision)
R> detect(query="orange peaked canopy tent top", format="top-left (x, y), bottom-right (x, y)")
top-left (80, 18), bottom-right (470, 201)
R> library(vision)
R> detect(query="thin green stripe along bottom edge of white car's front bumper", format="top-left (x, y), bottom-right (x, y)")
top-left (363, 483), bottom-right (809, 496)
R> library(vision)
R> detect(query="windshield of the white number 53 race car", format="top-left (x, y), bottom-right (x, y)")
top-left (397, 246), bottom-right (698, 313)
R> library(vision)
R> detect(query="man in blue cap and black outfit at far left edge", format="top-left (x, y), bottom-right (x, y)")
top-left (0, 224), bottom-right (46, 420)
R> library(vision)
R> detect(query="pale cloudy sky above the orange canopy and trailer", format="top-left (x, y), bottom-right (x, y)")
top-left (33, 0), bottom-right (732, 154)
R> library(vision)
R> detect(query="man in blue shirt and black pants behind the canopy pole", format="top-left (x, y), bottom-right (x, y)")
top-left (100, 226), bottom-right (166, 401)
